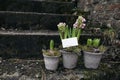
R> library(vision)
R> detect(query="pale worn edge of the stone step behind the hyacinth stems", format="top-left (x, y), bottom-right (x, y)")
top-left (0, 30), bottom-right (102, 37)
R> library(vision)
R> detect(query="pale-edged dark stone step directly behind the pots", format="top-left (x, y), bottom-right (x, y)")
top-left (0, 31), bottom-right (101, 58)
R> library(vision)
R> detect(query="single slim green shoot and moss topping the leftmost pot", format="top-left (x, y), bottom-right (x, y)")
top-left (42, 40), bottom-right (60, 56)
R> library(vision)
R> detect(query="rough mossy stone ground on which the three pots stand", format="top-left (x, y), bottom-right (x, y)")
top-left (0, 59), bottom-right (120, 80)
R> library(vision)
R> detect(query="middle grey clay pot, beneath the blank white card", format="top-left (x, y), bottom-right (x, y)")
top-left (61, 50), bottom-right (78, 69)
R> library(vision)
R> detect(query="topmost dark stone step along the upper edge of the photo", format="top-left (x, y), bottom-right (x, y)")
top-left (0, 0), bottom-right (75, 14)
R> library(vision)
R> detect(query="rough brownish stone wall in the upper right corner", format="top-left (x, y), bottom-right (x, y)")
top-left (78, 0), bottom-right (120, 30)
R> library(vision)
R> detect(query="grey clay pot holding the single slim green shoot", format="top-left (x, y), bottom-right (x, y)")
top-left (43, 54), bottom-right (60, 71)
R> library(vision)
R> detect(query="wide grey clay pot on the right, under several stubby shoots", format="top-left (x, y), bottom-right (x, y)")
top-left (84, 52), bottom-right (103, 69)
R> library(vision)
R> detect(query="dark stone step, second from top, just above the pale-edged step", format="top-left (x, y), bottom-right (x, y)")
top-left (0, 11), bottom-right (77, 30)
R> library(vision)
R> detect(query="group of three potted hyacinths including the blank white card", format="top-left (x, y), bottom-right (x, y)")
top-left (43, 16), bottom-right (106, 70)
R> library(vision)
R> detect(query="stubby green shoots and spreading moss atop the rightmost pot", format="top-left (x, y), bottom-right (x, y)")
top-left (82, 38), bottom-right (107, 53)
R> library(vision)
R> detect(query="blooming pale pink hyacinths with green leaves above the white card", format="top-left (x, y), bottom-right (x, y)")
top-left (57, 16), bottom-right (86, 40)
